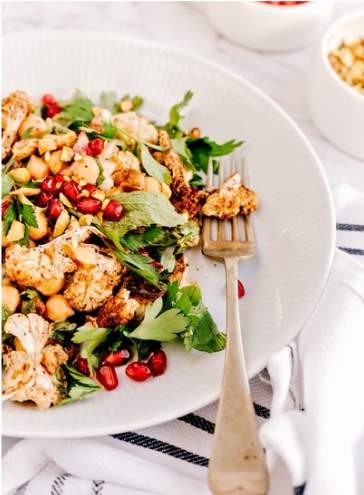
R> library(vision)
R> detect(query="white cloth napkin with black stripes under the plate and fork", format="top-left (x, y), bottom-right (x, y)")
top-left (2, 186), bottom-right (364, 495)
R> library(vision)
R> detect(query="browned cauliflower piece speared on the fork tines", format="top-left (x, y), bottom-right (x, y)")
top-left (201, 173), bottom-right (258, 220)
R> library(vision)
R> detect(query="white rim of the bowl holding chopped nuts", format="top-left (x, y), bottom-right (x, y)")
top-left (318, 9), bottom-right (364, 105)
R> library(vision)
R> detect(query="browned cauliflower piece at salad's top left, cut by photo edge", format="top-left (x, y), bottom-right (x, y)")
top-left (1, 91), bottom-right (35, 161)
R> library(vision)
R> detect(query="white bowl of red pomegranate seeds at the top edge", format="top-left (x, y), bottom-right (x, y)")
top-left (206, 1), bottom-right (335, 52)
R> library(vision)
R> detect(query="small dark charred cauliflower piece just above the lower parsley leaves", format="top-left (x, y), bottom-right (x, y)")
top-left (97, 288), bottom-right (139, 327)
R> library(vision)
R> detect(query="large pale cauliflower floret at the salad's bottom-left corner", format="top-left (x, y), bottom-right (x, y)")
top-left (1, 313), bottom-right (68, 410)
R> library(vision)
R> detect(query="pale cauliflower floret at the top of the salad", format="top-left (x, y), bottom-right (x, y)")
top-left (111, 112), bottom-right (158, 146)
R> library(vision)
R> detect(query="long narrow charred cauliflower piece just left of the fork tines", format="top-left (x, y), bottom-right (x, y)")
top-left (159, 131), bottom-right (200, 218)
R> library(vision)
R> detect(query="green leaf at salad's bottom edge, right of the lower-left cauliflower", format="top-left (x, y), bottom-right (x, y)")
top-left (57, 364), bottom-right (103, 407)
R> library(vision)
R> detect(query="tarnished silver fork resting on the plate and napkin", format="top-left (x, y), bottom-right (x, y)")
top-left (201, 159), bottom-right (269, 495)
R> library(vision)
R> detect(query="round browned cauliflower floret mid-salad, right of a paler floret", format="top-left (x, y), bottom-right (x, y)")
top-left (63, 244), bottom-right (125, 311)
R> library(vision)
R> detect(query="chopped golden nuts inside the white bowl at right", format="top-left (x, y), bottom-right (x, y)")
top-left (328, 37), bottom-right (364, 95)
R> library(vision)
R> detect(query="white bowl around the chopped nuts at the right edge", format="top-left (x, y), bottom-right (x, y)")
top-left (308, 10), bottom-right (364, 160)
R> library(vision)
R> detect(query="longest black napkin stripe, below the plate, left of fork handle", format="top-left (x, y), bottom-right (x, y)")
top-left (112, 431), bottom-right (209, 467)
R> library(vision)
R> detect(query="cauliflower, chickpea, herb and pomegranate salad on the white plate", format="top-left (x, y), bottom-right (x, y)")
top-left (1, 91), bottom-right (257, 410)
